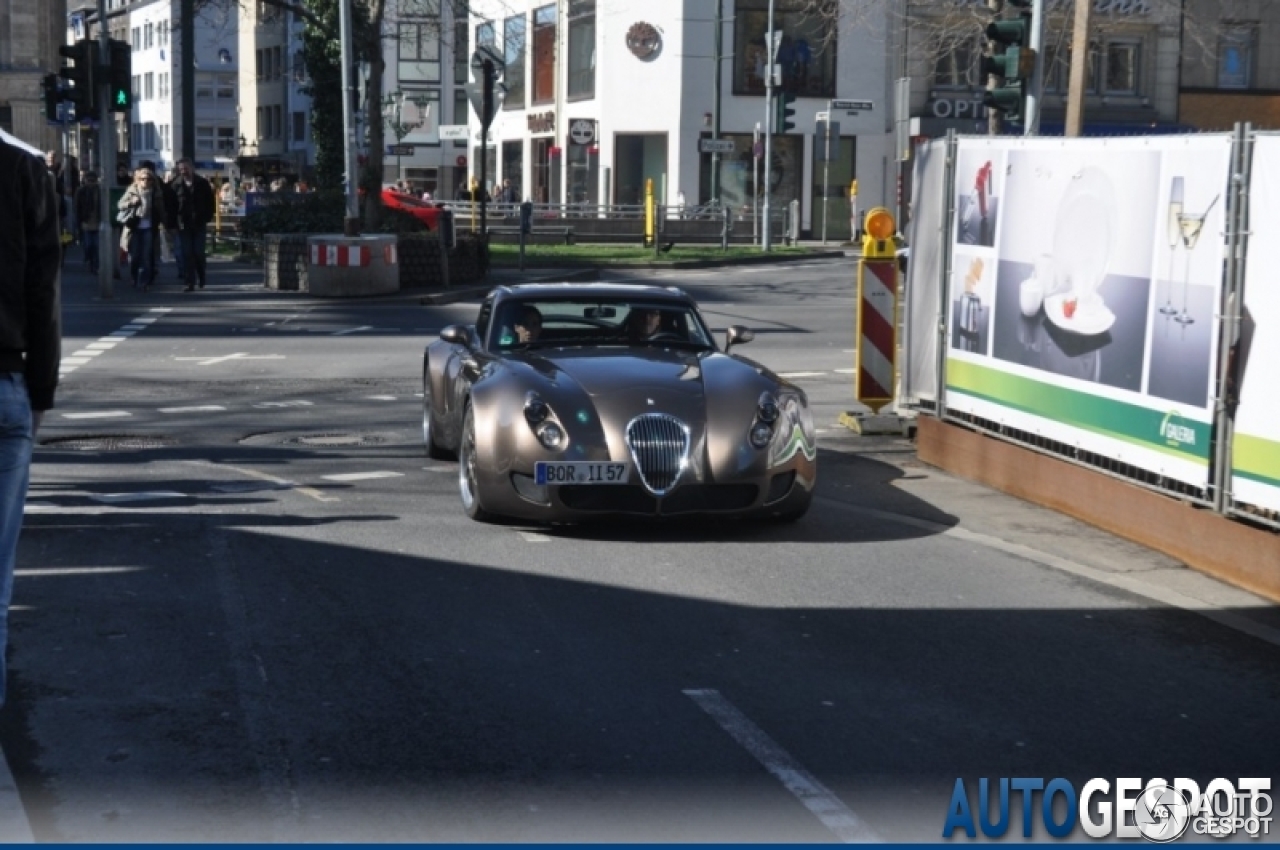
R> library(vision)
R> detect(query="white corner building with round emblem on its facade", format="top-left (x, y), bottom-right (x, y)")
top-left (468, 0), bottom-right (896, 237)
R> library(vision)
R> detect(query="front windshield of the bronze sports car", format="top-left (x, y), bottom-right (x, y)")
top-left (489, 297), bottom-right (714, 351)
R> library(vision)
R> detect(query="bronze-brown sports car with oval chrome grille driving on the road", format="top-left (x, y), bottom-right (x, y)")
top-left (422, 284), bottom-right (817, 522)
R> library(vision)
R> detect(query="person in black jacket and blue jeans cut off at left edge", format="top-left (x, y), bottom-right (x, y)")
top-left (0, 140), bottom-right (61, 705)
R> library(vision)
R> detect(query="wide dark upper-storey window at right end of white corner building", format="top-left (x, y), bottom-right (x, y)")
top-left (733, 0), bottom-right (836, 97)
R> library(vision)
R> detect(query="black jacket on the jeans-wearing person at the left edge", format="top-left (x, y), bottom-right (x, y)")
top-left (0, 141), bottom-right (61, 410)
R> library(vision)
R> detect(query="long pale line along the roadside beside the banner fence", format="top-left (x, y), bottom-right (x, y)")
top-left (814, 495), bottom-right (1280, 646)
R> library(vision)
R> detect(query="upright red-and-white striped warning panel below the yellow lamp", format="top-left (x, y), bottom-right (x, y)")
top-left (854, 260), bottom-right (897, 410)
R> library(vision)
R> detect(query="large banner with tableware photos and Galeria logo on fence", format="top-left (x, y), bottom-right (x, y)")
top-left (946, 134), bottom-right (1231, 486)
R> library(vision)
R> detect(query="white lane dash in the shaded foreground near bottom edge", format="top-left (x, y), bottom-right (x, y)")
top-left (685, 689), bottom-right (881, 844)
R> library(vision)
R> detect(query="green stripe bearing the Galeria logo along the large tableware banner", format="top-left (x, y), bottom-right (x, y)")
top-left (947, 358), bottom-right (1211, 466)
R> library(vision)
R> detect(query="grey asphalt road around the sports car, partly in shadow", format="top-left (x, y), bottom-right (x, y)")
top-left (0, 261), bottom-right (1280, 842)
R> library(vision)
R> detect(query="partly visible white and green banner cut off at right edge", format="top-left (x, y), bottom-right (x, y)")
top-left (1231, 136), bottom-right (1280, 511)
